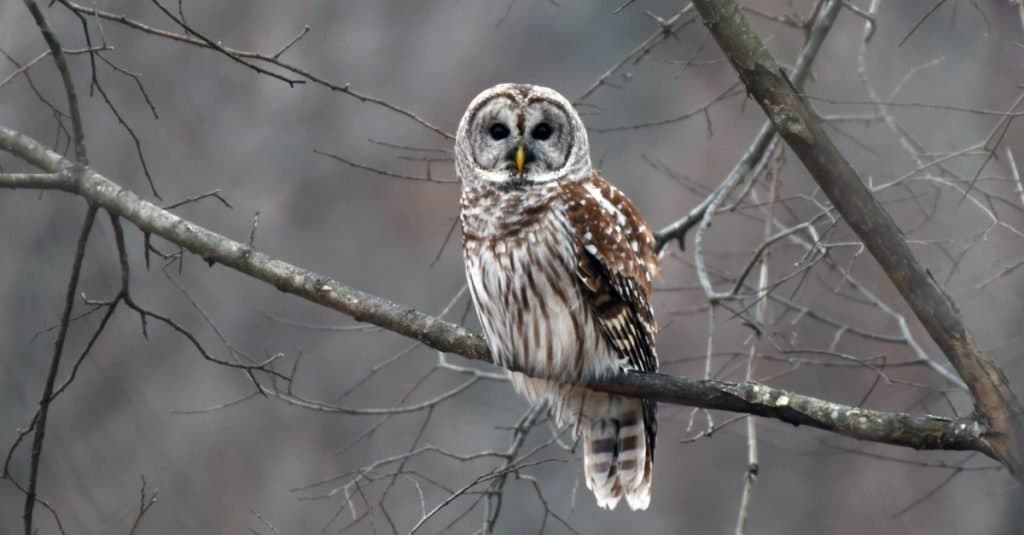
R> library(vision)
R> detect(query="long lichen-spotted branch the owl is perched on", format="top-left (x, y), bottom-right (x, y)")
top-left (0, 126), bottom-right (992, 455)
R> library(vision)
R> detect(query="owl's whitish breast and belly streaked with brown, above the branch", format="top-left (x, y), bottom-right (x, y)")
top-left (462, 183), bottom-right (607, 381)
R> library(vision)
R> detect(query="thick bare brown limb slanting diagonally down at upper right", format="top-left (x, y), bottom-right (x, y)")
top-left (693, 0), bottom-right (1024, 478)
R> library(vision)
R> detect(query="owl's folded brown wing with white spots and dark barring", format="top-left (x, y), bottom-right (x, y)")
top-left (566, 173), bottom-right (657, 372)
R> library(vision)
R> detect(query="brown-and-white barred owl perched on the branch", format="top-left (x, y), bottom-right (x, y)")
top-left (455, 84), bottom-right (657, 509)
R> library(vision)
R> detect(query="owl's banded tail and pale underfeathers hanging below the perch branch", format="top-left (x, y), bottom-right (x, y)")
top-left (510, 373), bottom-right (656, 510)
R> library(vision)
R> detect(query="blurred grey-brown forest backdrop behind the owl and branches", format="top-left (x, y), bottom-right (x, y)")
top-left (0, 0), bottom-right (1024, 535)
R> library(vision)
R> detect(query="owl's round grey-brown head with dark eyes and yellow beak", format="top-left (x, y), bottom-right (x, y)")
top-left (455, 84), bottom-right (591, 188)
